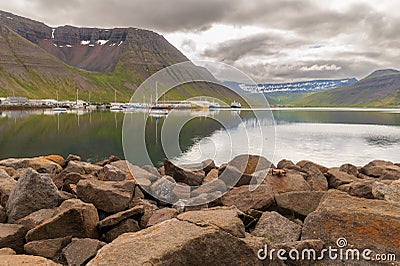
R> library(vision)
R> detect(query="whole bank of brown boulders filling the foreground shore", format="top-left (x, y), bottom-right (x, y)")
top-left (0, 155), bottom-right (400, 265)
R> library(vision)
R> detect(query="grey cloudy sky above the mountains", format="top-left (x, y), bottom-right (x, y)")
top-left (0, 0), bottom-right (400, 82)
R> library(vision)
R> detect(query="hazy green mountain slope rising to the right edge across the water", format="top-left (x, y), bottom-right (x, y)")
top-left (295, 69), bottom-right (400, 107)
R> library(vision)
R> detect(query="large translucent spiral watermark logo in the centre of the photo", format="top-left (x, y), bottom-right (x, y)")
top-left (122, 61), bottom-right (275, 206)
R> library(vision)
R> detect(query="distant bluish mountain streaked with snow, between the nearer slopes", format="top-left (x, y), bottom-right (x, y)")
top-left (224, 78), bottom-right (357, 105)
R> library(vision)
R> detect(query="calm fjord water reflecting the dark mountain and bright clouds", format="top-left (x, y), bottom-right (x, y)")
top-left (0, 109), bottom-right (400, 166)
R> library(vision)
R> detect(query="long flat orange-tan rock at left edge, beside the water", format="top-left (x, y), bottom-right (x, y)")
top-left (0, 157), bottom-right (62, 175)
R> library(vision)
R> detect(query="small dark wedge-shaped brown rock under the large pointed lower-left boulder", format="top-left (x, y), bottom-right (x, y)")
top-left (24, 237), bottom-right (71, 259)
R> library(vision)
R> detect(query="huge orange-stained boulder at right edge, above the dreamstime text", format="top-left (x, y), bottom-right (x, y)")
top-left (302, 190), bottom-right (400, 254)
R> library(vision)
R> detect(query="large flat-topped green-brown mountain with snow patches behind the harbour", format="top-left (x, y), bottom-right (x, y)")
top-left (0, 11), bottom-right (236, 101)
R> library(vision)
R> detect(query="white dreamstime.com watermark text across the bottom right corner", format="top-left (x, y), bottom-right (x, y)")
top-left (257, 238), bottom-right (396, 262)
